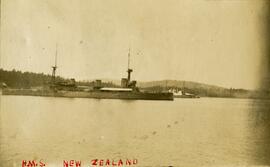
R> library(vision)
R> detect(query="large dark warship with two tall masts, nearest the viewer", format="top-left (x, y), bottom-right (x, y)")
top-left (2, 51), bottom-right (173, 100)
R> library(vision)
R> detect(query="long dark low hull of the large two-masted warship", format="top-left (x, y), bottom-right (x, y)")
top-left (2, 89), bottom-right (173, 100)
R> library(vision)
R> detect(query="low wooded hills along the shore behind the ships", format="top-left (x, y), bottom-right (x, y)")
top-left (0, 69), bottom-right (270, 99)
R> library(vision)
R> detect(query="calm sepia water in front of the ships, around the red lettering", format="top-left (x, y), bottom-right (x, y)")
top-left (0, 96), bottom-right (270, 167)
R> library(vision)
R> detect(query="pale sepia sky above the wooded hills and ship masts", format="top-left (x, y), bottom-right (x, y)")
top-left (0, 0), bottom-right (266, 89)
